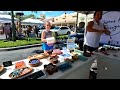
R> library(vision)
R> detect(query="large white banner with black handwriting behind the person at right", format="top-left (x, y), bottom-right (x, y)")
top-left (100, 11), bottom-right (120, 46)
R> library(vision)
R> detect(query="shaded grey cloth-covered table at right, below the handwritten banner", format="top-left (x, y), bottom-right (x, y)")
top-left (95, 51), bottom-right (120, 79)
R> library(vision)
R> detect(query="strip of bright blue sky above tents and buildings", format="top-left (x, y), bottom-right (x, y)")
top-left (23, 11), bottom-right (74, 18)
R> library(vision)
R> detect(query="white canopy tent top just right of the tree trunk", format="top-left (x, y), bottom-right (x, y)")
top-left (21, 18), bottom-right (44, 25)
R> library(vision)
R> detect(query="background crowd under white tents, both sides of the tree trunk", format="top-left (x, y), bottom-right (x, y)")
top-left (0, 23), bottom-right (39, 39)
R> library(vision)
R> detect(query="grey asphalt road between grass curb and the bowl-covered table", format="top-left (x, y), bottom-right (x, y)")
top-left (0, 44), bottom-right (41, 64)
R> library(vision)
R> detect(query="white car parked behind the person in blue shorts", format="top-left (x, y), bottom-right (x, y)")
top-left (51, 26), bottom-right (71, 35)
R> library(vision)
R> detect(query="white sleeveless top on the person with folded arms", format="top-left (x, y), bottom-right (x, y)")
top-left (84, 20), bottom-right (104, 47)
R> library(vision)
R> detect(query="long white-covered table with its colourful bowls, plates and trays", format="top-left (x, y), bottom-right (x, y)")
top-left (0, 42), bottom-right (96, 79)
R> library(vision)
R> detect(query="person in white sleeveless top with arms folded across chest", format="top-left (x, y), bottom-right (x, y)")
top-left (84, 11), bottom-right (111, 56)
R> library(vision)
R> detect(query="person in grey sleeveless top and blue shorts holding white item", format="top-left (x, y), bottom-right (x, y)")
top-left (41, 21), bottom-right (55, 54)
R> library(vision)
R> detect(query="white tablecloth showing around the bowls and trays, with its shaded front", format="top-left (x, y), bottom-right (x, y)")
top-left (0, 53), bottom-right (96, 79)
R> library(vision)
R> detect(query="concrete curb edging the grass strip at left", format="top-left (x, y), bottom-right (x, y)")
top-left (0, 44), bottom-right (42, 51)
